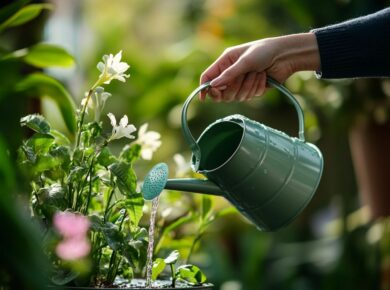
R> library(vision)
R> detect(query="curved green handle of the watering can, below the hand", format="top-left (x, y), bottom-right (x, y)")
top-left (181, 77), bottom-right (305, 171)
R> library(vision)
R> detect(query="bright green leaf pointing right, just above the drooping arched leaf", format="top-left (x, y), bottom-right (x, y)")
top-left (23, 43), bottom-right (74, 68)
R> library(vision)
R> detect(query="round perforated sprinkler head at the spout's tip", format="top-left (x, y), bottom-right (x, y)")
top-left (142, 163), bottom-right (169, 200)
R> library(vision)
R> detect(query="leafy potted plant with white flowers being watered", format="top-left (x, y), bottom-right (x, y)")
top-left (18, 52), bottom-right (215, 289)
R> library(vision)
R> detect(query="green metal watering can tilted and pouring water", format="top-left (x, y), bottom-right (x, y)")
top-left (142, 78), bottom-right (323, 231)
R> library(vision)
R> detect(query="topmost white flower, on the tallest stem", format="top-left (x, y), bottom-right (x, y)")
top-left (96, 51), bottom-right (130, 85)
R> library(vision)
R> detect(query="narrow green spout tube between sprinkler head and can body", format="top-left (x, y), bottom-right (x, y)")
top-left (165, 178), bottom-right (225, 196)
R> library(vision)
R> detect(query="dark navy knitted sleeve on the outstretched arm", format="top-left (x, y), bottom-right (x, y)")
top-left (312, 8), bottom-right (390, 78)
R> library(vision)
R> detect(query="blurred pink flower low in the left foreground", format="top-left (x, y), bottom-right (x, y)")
top-left (53, 212), bottom-right (91, 261)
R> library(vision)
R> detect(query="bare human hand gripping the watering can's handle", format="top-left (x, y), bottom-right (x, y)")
top-left (200, 33), bottom-right (320, 102)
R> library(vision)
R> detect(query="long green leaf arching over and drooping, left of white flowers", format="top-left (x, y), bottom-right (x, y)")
top-left (17, 73), bottom-right (76, 133)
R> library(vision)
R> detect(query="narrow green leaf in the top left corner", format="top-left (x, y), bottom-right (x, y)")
top-left (0, 4), bottom-right (53, 31)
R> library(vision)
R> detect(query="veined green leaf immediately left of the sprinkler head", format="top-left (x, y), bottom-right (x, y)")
top-left (108, 162), bottom-right (137, 196)
